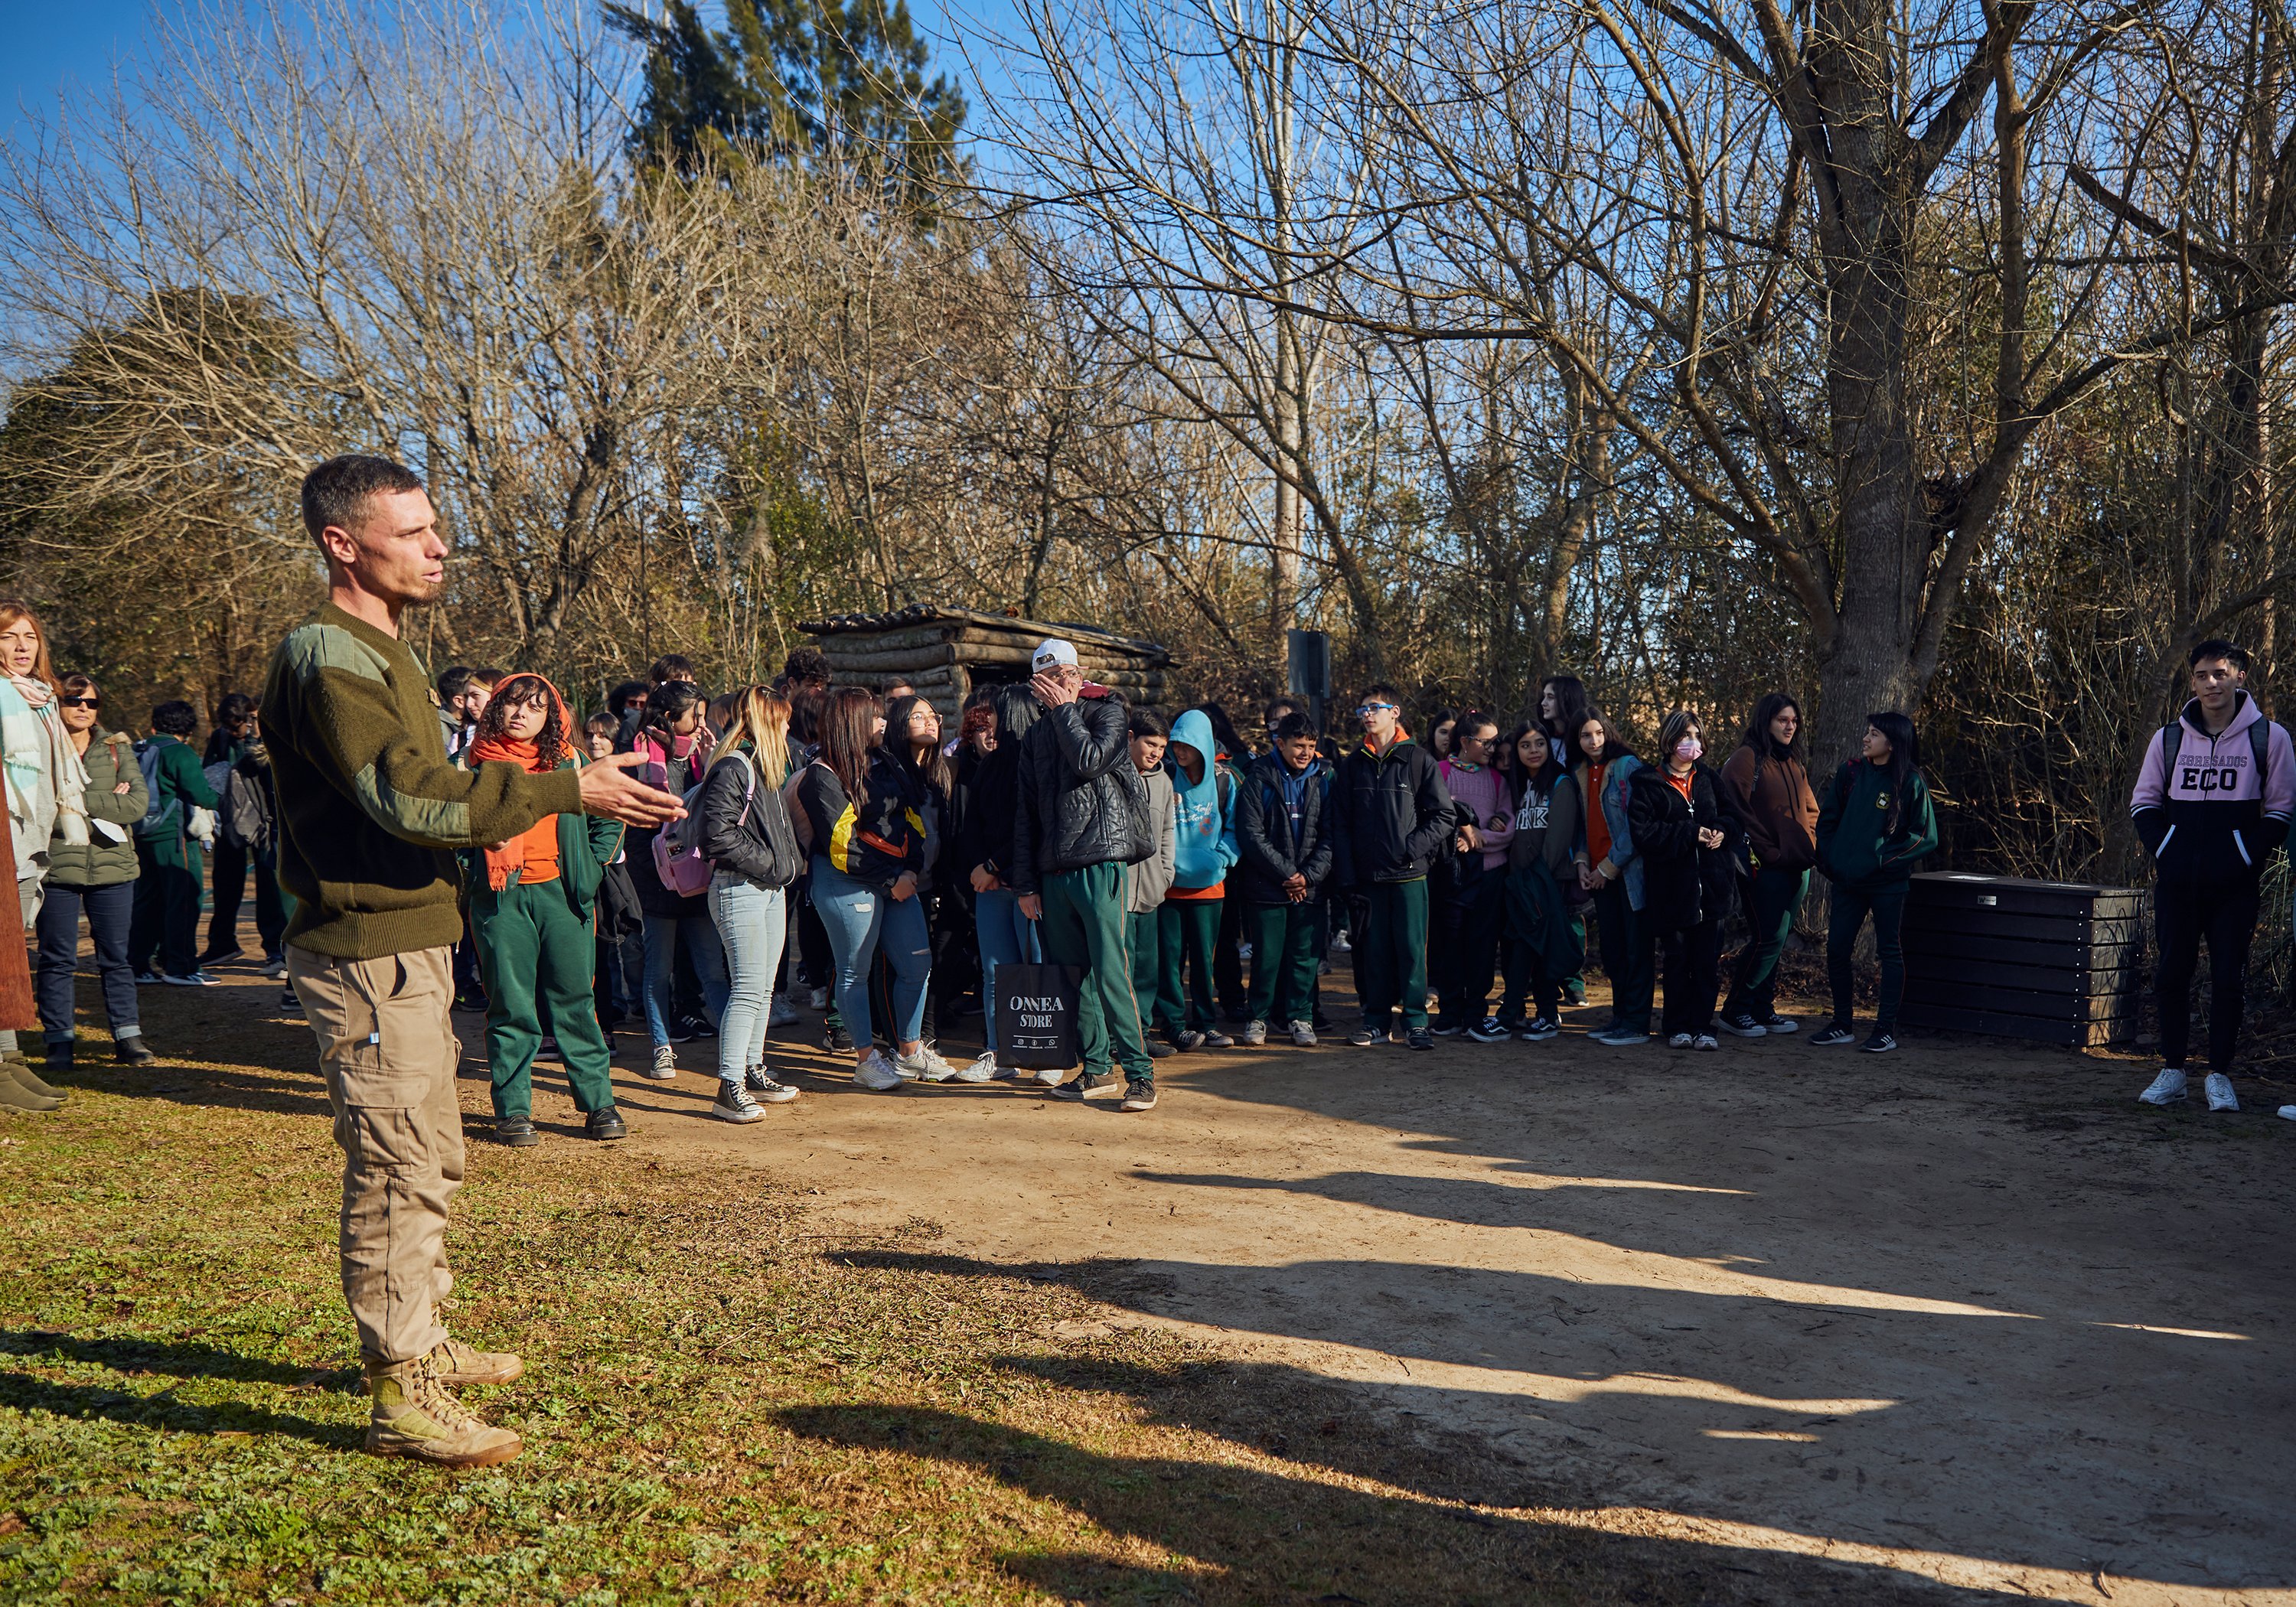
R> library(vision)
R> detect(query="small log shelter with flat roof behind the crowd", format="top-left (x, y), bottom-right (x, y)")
top-left (797, 604), bottom-right (1171, 721)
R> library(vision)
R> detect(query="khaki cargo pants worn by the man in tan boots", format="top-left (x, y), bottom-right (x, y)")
top-left (287, 944), bottom-right (461, 1361)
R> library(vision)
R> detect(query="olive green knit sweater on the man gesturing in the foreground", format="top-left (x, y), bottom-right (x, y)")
top-left (262, 604), bottom-right (581, 960)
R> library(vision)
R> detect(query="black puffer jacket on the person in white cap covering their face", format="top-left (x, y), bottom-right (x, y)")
top-left (1006, 691), bottom-right (1155, 893)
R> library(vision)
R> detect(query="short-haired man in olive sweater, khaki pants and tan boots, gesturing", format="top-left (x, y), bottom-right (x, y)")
top-left (262, 457), bottom-right (682, 1467)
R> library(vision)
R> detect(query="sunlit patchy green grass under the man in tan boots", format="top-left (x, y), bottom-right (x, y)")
top-left (0, 1033), bottom-right (1938, 1602)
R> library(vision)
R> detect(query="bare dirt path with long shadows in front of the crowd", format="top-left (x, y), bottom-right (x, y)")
top-left (583, 987), bottom-right (2296, 1605)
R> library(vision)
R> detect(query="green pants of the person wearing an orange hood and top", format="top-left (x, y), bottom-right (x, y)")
top-left (471, 882), bottom-right (613, 1116)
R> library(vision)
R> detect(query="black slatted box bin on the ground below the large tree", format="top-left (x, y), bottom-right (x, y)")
top-left (1899, 870), bottom-right (2149, 1047)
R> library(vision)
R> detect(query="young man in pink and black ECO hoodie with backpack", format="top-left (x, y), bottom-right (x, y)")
top-left (2128, 641), bottom-right (2296, 1111)
